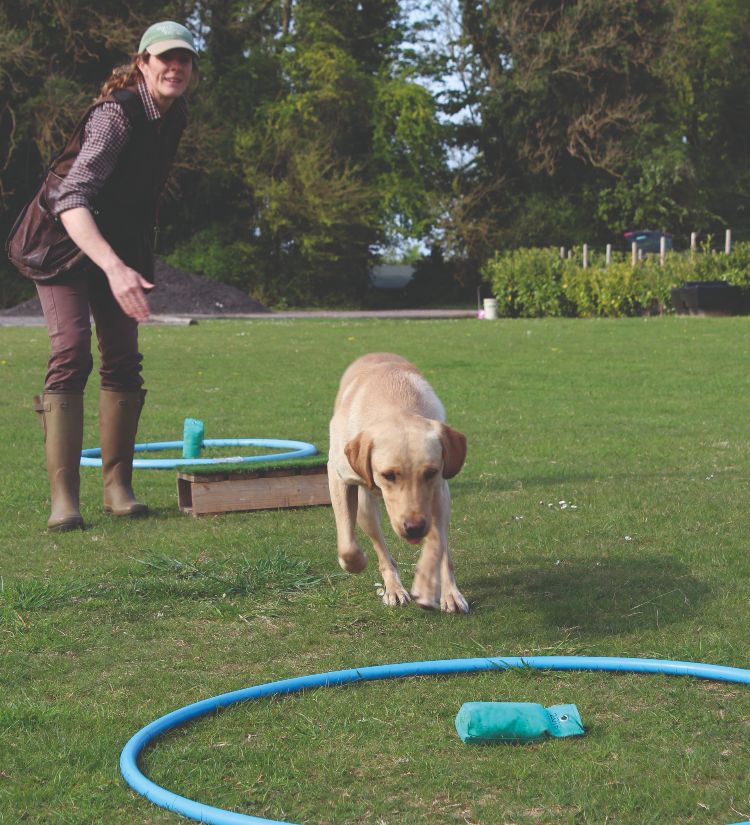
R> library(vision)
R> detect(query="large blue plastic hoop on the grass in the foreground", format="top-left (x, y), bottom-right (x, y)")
top-left (120, 656), bottom-right (750, 825)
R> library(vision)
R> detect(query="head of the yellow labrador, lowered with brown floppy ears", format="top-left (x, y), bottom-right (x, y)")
top-left (344, 415), bottom-right (466, 544)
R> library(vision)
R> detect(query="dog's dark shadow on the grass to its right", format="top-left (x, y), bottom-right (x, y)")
top-left (463, 556), bottom-right (711, 636)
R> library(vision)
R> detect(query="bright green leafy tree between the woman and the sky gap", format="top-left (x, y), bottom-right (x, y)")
top-left (174, 0), bottom-right (450, 303)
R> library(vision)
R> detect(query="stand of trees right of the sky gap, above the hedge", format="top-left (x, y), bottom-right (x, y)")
top-left (440, 0), bottom-right (750, 270)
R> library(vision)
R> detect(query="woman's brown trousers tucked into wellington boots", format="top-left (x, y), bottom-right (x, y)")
top-left (36, 263), bottom-right (143, 393)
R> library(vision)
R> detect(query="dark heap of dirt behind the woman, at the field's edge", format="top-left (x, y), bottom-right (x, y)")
top-left (0, 258), bottom-right (270, 316)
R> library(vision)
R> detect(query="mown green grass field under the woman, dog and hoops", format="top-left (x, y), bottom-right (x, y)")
top-left (0, 317), bottom-right (750, 825)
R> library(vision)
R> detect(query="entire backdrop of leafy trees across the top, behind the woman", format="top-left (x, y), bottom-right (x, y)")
top-left (0, 0), bottom-right (750, 303)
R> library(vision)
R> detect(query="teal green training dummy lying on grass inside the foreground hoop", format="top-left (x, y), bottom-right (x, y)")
top-left (456, 702), bottom-right (584, 745)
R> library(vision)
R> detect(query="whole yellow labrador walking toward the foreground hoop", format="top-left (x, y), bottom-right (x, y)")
top-left (328, 352), bottom-right (469, 613)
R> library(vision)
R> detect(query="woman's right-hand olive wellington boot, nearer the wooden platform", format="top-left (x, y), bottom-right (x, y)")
top-left (99, 389), bottom-right (148, 516)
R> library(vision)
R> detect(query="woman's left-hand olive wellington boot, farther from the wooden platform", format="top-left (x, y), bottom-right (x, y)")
top-left (34, 392), bottom-right (84, 532)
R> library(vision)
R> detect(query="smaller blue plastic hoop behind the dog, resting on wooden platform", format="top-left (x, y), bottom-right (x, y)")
top-left (81, 438), bottom-right (318, 470)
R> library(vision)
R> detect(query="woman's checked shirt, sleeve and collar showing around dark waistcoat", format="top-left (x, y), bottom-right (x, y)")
top-left (53, 81), bottom-right (186, 215)
